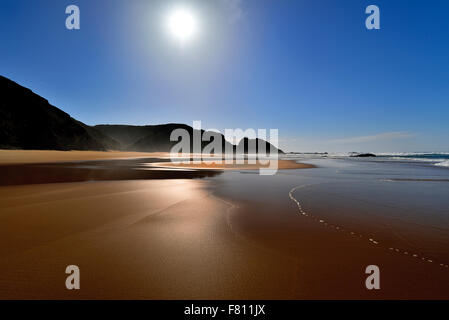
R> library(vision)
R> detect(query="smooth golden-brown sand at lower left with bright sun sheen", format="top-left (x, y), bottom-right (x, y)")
top-left (0, 180), bottom-right (300, 299)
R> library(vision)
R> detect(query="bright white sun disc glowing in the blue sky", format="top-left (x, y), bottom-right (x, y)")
top-left (167, 8), bottom-right (198, 44)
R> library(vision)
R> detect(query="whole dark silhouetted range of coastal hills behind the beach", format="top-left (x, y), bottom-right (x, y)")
top-left (0, 76), bottom-right (283, 153)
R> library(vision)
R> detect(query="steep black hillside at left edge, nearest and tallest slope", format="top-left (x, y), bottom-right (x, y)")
top-left (0, 76), bottom-right (118, 150)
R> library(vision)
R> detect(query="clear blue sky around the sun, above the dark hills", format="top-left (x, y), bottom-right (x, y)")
top-left (0, 0), bottom-right (449, 152)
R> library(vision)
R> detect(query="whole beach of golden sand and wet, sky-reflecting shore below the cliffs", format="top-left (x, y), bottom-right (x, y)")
top-left (0, 151), bottom-right (449, 299)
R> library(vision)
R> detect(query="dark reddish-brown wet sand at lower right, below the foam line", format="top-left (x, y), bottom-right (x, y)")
top-left (226, 191), bottom-right (449, 299)
